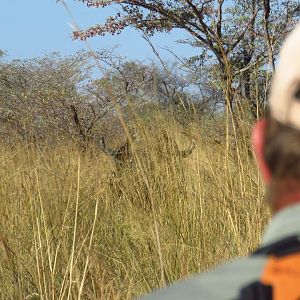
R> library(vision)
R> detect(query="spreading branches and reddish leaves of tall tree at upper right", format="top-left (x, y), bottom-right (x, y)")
top-left (74, 0), bottom-right (300, 113)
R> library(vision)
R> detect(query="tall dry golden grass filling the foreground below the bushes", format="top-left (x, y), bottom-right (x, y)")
top-left (0, 113), bottom-right (269, 299)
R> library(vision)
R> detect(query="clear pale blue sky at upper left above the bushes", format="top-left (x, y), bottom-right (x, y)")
top-left (0, 0), bottom-right (197, 60)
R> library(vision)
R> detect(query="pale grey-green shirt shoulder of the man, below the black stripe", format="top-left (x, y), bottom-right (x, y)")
top-left (141, 256), bottom-right (266, 300)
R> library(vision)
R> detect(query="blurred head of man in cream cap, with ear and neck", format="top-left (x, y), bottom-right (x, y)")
top-left (252, 24), bottom-right (300, 211)
